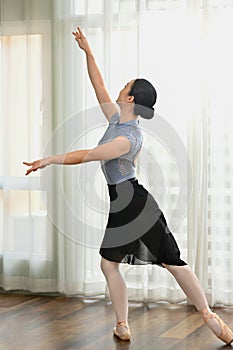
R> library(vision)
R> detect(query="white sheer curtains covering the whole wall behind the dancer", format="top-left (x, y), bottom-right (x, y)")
top-left (0, 0), bottom-right (233, 305)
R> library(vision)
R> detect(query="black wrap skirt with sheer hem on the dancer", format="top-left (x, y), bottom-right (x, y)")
top-left (99, 178), bottom-right (186, 266)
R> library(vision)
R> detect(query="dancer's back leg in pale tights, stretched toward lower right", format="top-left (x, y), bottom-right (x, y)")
top-left (163, 264), bottom-right (222, 336)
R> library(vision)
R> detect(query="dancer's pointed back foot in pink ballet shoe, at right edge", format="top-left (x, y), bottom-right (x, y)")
top-left (201, 309), bottom-right (233, 345)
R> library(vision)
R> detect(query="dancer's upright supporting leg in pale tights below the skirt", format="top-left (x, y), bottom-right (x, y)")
top-left (101, 258), bottom-right (128, 334)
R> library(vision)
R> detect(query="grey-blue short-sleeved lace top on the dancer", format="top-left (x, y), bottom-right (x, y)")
top-left (98, 113), bottom-right (143, 184)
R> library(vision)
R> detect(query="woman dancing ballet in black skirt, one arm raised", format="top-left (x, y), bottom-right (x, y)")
top-left (24, 27), bottom-right (233, 344)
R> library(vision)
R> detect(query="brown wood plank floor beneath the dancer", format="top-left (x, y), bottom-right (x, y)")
top-left (0, 293), bottom-right (233, 350)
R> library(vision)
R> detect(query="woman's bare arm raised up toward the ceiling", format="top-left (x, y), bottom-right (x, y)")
top-left (72, 27), bottom-right (118, 120)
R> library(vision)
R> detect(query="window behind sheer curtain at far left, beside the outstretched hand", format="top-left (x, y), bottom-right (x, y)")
top-left (0, 22), bottom-right (51, 259)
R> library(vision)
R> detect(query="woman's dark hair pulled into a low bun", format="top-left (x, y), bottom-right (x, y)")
top-left (129, 79), bottom-right (157, 119)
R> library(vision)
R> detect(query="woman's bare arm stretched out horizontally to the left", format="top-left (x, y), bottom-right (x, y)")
top-left (23, 136), bottom-right (130, 175)
